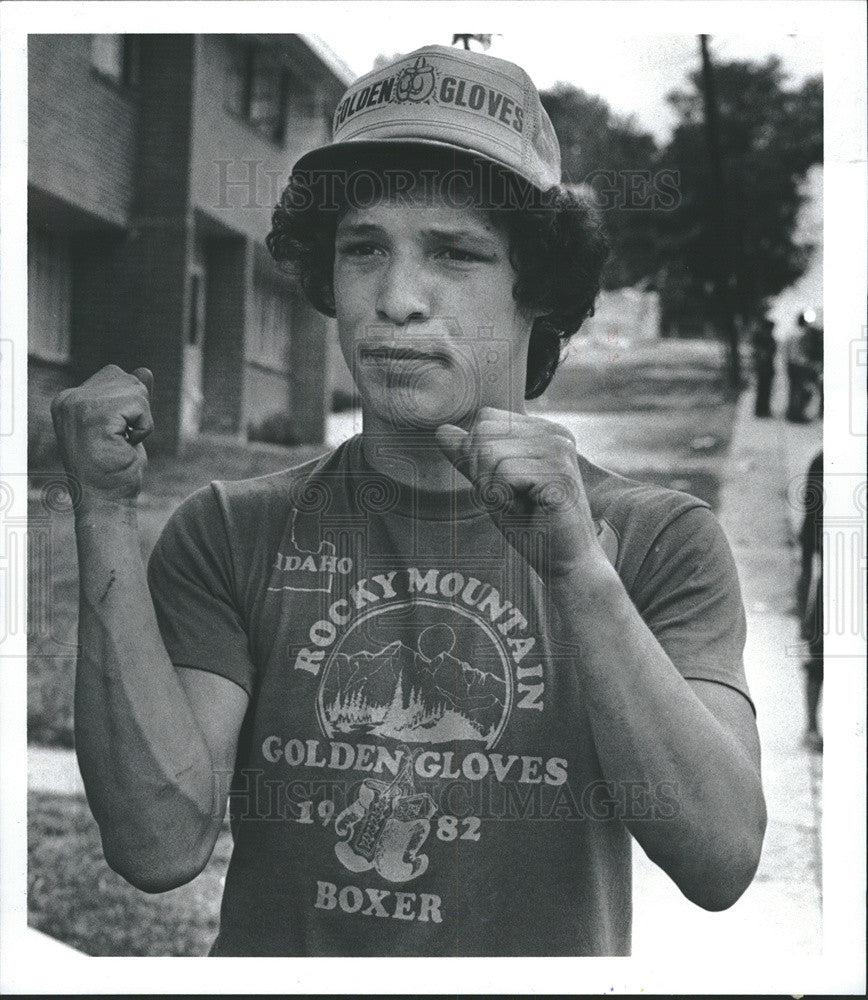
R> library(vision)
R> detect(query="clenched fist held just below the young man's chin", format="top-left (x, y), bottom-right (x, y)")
top-left (435, 406), bottom-right (605, 580)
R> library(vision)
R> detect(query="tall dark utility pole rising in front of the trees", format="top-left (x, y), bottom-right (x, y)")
top-left (699, 35), bottom-right (741, 389)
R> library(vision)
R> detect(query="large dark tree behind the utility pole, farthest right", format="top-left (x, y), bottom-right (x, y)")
top-left (658, 56), bottom-right (823, 334)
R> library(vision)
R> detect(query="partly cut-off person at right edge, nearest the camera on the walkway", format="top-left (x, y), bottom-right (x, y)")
top-left (797, 451), bottom-right (823, 752)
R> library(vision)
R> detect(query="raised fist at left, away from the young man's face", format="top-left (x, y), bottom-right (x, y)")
top-left (51, 365), bottom-right (154, 501)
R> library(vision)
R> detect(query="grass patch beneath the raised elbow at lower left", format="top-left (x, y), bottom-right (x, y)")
top-left (27, 792), bottom-right (232, 956)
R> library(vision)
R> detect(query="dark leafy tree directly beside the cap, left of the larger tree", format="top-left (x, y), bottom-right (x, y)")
top-left (540, 83), bottom-right (660, 288)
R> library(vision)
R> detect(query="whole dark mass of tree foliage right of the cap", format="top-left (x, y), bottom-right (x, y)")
top-left (541, 57), bottom-right (823, 329)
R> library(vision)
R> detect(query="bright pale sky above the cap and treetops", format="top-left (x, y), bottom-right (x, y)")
top-left (318, 31), bottom-right (823, 141)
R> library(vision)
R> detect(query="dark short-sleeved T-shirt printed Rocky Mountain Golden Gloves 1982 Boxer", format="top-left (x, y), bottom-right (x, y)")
top-left (149, 437), bottom-right (749, 956)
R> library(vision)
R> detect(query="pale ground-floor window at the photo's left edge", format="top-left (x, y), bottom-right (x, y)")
top-left (27, 231), bottom-right (72, 361)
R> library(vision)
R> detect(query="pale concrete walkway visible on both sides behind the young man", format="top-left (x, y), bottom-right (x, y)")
top-left (29, 392), bottom-right (822, 961)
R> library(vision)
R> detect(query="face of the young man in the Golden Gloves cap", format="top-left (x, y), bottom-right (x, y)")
top-left (334, 193), bottom-right (533, 430)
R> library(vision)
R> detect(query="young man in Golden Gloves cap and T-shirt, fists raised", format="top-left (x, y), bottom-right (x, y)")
top-left (54, 46), bottom-right (765, 955)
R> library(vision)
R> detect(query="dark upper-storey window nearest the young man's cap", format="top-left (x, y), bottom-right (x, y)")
top-left (223, 42), bottom-right (289, 143)
